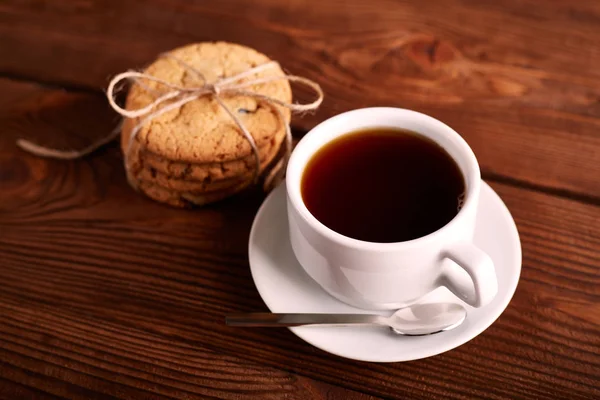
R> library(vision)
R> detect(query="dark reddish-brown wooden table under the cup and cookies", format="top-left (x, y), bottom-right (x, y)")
top-left (0, 0), bottom-right (600, 399)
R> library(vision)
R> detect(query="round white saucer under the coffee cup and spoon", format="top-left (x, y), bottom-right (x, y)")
top-left (249, 183), bottom-right (521, 362)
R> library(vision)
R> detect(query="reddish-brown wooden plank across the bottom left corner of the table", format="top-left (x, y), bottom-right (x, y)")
top-left (0, 296), bottom-right (373, 400)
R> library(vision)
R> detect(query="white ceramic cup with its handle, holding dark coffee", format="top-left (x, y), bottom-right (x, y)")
top-left (286, 107), bottom-right (498, 310)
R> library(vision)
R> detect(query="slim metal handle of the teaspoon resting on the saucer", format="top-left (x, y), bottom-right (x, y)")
top-left (225, 313), bottom-right (387, 328)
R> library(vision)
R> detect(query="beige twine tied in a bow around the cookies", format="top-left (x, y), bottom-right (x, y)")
top-left (17, 54), bottom-right (323, 194)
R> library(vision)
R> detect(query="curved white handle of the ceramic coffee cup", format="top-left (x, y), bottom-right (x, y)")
top-left (442, 242), bottom-right (498, 307)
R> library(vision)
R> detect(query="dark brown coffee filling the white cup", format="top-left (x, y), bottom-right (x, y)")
top-left (301, 128), bottom-right (465, 243)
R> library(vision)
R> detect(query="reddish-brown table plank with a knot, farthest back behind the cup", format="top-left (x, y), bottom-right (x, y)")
top-left (0, 0), bottom-right (600, 201)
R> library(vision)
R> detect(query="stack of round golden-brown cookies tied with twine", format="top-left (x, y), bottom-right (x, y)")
top-left (121, 42), bottom-right (292, 207)
